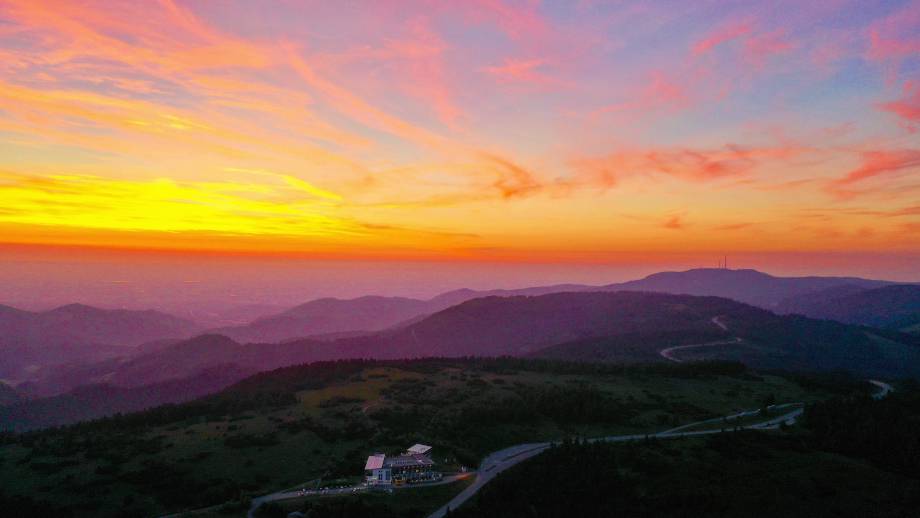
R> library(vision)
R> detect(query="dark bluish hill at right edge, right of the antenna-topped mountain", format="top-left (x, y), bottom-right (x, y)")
top-left (779, 284), bottom-right (920, 332)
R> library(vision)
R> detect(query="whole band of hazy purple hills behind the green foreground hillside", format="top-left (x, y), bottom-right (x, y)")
top-left (0, 269), bottom-right (920, 427)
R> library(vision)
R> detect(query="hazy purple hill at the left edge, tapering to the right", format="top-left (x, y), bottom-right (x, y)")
top-left (0, 304), bottom-right (197, 380)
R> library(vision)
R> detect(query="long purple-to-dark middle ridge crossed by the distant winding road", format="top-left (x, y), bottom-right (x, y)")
top-left (66, 292), bottom-right (920, 398)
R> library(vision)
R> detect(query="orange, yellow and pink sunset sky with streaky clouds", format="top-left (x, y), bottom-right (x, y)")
top-left (0, 0), bottom-right (920, 308)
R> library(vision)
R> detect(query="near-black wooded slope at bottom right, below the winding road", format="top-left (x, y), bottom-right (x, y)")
top-left (451, 388), bottom-right (920, 518)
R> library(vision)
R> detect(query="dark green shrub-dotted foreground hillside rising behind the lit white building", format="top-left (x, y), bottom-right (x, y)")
top-left (0, 358), bottom-right (864, 516)
